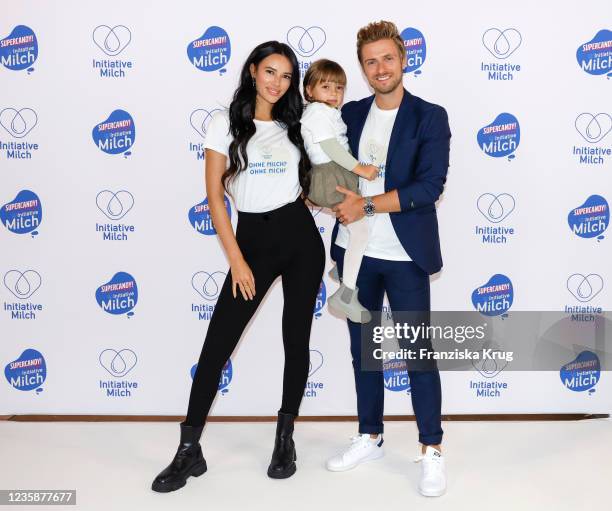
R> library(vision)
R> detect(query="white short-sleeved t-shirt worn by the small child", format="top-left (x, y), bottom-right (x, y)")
top-left (300, 101), bottom-right (349, 165)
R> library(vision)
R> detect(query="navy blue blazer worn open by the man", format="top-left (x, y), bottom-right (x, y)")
top-left (330, 89), bottom-right (451, 275)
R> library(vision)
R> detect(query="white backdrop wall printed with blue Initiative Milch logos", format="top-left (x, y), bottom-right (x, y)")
top-left (0, 0), bottom-right (612, 415)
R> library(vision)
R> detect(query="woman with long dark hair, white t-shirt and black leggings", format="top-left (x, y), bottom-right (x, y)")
top-left (152, 41), bottom-right (325, 492)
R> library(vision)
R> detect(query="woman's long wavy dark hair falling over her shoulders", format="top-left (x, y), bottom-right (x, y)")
top-left (221, 41), bottom-right (310, 196)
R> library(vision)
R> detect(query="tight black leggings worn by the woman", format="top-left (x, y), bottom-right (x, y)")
top-left (185, 198), bottom-right (325, 426)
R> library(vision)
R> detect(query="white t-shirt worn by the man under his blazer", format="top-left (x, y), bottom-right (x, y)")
top-left (336, 101), bottom-right (412, 261)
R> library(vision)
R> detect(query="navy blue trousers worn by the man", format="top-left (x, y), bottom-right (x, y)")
top-left (334, 246), bottom-right (443, 445)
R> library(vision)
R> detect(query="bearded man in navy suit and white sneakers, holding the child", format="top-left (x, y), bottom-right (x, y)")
top-left (327, 21), bottom-right (451, 496)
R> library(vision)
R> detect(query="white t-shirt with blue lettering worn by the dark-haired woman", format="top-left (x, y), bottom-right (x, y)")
top-left (204, 110), bottom-right (302, 213)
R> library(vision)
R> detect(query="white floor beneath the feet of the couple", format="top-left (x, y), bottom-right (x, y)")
top-left (0, 420), bottom-right (612, 511)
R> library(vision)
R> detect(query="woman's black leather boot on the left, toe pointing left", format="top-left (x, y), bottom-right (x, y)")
top-left (151, 422), bottom-right (206, 493)
